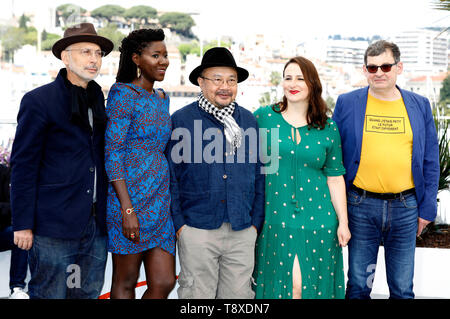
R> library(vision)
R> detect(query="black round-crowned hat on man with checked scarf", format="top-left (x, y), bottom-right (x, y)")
top-left (189, 47), bottom-right (248, 86)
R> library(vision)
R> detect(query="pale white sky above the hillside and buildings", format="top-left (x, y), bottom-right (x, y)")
top-left (0, 0), bottom-right (450, 40)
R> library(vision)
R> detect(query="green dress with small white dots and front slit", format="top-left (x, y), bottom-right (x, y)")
top-left (253, 106), bottom-right (345, 299)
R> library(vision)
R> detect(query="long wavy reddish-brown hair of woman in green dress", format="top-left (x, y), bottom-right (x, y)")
top-left (272, 56), bottom-right (330, 129)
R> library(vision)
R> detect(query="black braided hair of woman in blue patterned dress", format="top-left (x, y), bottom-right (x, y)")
top-left (116, 29), bottom-right (165, 83)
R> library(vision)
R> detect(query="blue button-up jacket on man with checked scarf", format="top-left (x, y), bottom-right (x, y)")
top-left (166, 102), bottom-right (265, 231)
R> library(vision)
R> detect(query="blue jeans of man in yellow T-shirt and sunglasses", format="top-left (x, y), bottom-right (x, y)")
top-left (346, 190), bottom-right (418, 299)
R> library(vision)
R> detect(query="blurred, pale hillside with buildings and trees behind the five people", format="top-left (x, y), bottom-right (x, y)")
top-left (0, 6), bottom-right (450, 139)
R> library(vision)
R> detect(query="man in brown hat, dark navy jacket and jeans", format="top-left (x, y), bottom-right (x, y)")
top-left (11, 23), bottom-right (114, 299)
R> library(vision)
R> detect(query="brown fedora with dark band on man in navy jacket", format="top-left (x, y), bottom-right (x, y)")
top-left (52, 23), bottom-right (114, 59)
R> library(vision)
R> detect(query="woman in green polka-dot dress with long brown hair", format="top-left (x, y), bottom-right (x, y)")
top-left (253, 57), bottom-right (350, 299)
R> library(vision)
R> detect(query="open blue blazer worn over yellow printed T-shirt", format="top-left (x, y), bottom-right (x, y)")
top-left (333, 86), bottom-right (439, 221)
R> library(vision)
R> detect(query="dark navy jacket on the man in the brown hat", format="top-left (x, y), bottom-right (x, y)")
top-left (11, 69), bottom-right (107, 239)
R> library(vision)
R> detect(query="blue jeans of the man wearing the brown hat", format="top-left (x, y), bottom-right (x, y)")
top-left (28, 216), bottom-right (107, 299)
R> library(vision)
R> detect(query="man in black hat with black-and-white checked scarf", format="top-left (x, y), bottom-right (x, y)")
top-left (166, 47), bottom-right (264, 299)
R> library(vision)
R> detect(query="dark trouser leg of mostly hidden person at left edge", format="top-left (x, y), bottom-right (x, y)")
top-left (0, 226), bottom-right (28, 290)
